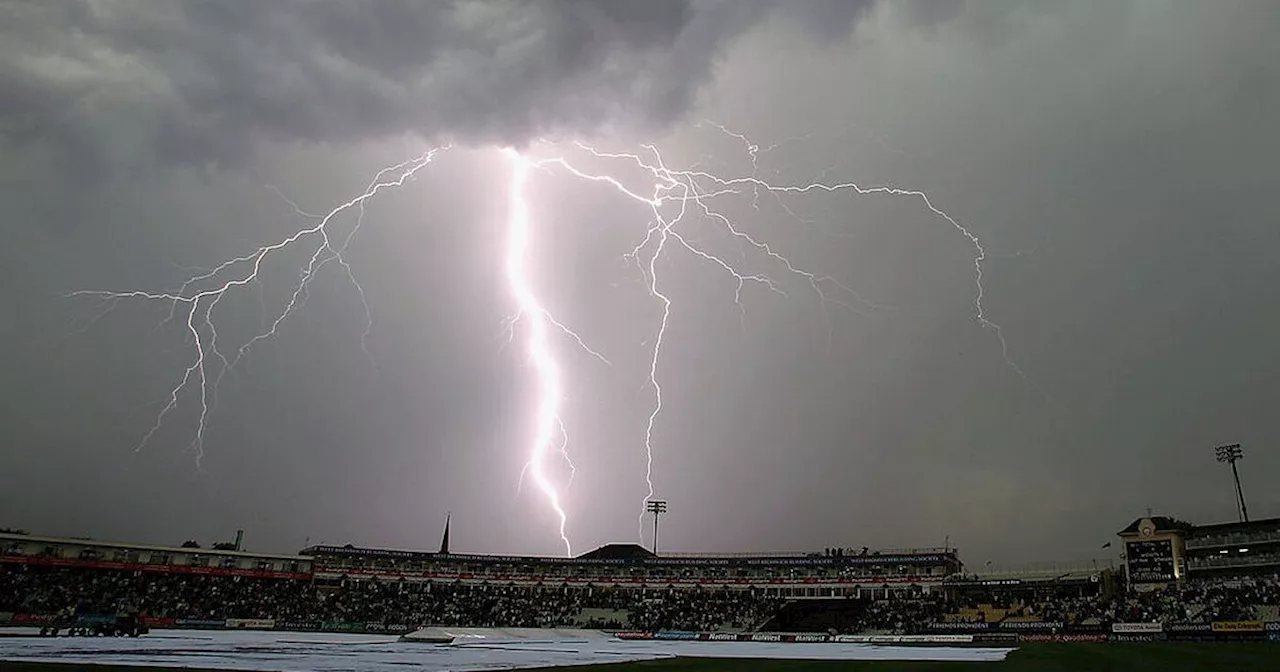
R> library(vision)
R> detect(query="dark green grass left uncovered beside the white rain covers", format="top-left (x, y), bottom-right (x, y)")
top-left (0, 643), bottom-right (1280, 672)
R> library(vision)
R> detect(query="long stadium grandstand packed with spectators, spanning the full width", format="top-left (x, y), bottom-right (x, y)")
top-left (0, 515), bottom-right (1280, 639)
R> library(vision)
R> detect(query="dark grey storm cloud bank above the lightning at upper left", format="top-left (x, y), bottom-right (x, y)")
top-left (0, 0), bottom-right (867, 165)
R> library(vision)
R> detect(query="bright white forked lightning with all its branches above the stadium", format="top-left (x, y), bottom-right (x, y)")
top-left (72, 122), bottom-right (1021, 553)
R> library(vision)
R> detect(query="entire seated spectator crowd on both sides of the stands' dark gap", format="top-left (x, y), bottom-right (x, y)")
top-left (0, 564), bottom-right (1280, 632)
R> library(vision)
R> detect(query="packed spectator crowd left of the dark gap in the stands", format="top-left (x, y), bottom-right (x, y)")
top-left (0, 566), bottom-right (778, 630)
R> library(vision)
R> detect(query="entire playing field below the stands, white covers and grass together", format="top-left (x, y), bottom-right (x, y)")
top-left (0, 631), bottom-right (1280, 672)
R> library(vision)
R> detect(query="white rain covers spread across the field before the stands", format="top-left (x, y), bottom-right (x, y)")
top-left (0, 628), bottom-right (1011, 672)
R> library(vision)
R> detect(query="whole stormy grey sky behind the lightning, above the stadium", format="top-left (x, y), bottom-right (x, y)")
top-left (0, 0), bottom-right (1280, 564)
